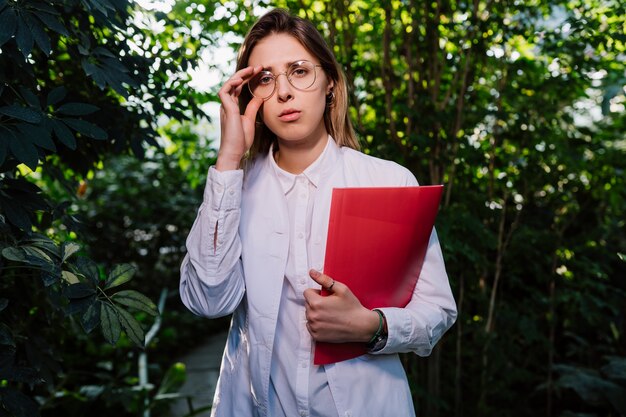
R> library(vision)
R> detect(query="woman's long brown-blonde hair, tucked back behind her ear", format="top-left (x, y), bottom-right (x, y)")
top-left (237, 9), bottom-right (360, 159)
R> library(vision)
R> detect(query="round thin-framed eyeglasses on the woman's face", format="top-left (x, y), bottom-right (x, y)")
top-left (248, 61), bottom-right (321, 100)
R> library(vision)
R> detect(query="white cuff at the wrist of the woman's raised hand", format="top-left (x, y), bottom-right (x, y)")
top-left (204, 166), bottom-right (243, 210)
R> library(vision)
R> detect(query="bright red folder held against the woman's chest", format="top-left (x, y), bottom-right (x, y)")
top-left (313, 185), bottom-right (443, 365)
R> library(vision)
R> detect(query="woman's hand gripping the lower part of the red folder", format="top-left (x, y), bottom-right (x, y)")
top-left (304, 269), bottom-right (379, 343)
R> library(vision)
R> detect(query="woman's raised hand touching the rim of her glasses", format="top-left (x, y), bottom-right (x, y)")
top-left (215, 66), bottom-right (263, 171)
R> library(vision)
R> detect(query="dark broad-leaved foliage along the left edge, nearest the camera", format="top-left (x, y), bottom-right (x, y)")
top-left (0, 0), bottom-right (210, 416)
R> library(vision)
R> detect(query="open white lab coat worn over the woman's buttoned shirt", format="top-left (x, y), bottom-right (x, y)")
top-left (180, 141), bottom-right (456, 417)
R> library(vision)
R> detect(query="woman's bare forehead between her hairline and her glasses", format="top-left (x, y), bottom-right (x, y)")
top-left (248, 33), bottom-right (318, 71)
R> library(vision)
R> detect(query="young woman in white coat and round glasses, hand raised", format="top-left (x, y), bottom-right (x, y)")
top-left (180, 10), bottom-right (456, 417)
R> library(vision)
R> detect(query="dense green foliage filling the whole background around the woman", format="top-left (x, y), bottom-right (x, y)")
top-left (0, 0), bottom-right (626, 417)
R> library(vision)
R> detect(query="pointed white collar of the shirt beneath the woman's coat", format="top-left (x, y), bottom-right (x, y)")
top-left (268, 135), bottom-right (339, 194)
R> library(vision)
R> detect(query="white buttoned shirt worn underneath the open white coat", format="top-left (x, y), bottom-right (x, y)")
top-left (269, 139), bottom-right (337, 417)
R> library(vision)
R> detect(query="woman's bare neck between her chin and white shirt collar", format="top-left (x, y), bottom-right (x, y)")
top-left (274, 128), bottom-right (328, 175)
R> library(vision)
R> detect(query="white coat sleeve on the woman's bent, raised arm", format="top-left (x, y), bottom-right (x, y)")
top-left (180, 167), bottom-right (245, 317)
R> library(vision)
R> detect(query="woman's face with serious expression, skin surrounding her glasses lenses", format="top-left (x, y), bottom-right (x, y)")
top-left (248, 34), bottom-right (333, 146)
